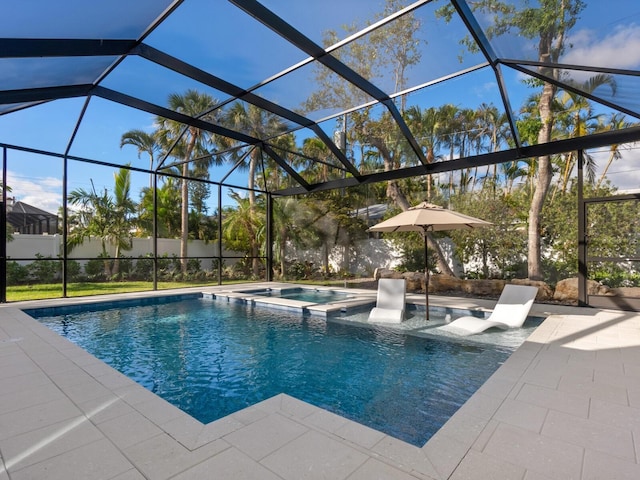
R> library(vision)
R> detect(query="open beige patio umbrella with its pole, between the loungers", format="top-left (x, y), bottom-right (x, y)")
top-left (369, 202), bottom-right (493, 320)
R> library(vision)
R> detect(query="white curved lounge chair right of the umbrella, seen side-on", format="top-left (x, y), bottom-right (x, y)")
top-left (441, 285), bottom-right (538, 335)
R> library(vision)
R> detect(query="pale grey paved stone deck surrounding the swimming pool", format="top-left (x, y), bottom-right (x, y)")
top-left (0, 284), bottom-right (640, 480)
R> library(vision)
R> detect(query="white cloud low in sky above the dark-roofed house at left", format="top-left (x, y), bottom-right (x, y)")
top-left (7, 171), bottom-right (62, 214)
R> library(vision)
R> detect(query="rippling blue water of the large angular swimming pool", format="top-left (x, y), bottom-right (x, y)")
top-left (27, 298), bottom-right (512, 446)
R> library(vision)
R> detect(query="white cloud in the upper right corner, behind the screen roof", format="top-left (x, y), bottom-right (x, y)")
top-left (561, 24), bottom-right (640, 69)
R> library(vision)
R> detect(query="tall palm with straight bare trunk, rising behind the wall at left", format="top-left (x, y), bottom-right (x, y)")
top-left (157, 89), bottom-right (218, 273)
